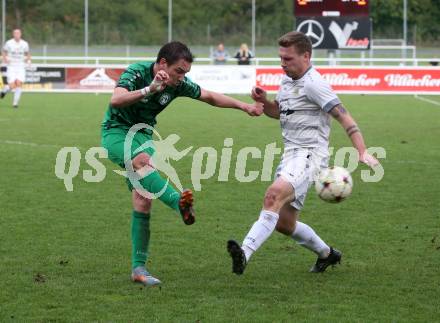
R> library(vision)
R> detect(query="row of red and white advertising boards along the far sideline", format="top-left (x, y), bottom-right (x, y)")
top-left (9, 64), bottom-right (440, 95)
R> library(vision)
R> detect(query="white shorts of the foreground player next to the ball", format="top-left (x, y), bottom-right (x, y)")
top-left (276, 148), bottom-right (328, 210)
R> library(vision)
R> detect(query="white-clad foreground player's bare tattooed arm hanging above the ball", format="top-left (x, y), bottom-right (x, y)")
top-left (330, 104), bottom-right (379, 167)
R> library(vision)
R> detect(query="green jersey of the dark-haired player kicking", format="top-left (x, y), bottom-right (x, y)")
top-left (102, 63), bottom-right (201, 129)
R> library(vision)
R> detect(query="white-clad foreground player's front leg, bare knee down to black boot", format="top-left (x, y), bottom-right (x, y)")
top-left (227, 177), bottom-right (294, 275)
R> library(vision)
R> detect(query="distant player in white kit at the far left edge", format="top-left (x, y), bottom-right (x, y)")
top-left (0, 28), bottom-right (31, 108)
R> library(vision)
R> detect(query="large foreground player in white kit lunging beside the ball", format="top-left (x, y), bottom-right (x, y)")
top-left (227, 31), bottom-right (379, 275)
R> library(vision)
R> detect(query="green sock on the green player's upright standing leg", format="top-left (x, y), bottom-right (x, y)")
top-left (131, 210), bottom-right (150, 268)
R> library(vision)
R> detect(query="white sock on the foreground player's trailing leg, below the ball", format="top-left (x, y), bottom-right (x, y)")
top-left (292, 221), bottom-right (330, 258)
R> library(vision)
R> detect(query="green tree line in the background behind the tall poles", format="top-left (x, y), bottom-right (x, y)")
top-left (6, 0), bottom-right (440, 46)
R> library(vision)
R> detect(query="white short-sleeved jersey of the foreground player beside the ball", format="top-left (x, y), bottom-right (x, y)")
top-left (276, 66), bottom-right (341, 151)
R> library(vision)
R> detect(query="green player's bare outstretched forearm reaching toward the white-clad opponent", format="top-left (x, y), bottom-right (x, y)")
top-left (199, 89), bottom-right (263, 116)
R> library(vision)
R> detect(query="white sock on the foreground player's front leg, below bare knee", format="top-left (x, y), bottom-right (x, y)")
top-left (242, 210), bottom-right (279, 261)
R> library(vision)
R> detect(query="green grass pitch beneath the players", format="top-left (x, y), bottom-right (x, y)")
top-left (0, 93), bottom-right (440, 322)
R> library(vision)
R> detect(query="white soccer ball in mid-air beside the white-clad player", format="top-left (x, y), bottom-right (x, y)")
top-left (315, 166), bottom-right (353, 203)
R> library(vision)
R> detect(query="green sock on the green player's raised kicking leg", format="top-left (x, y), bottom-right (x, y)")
top-left (140, 170), bottom-right (180, 212)
